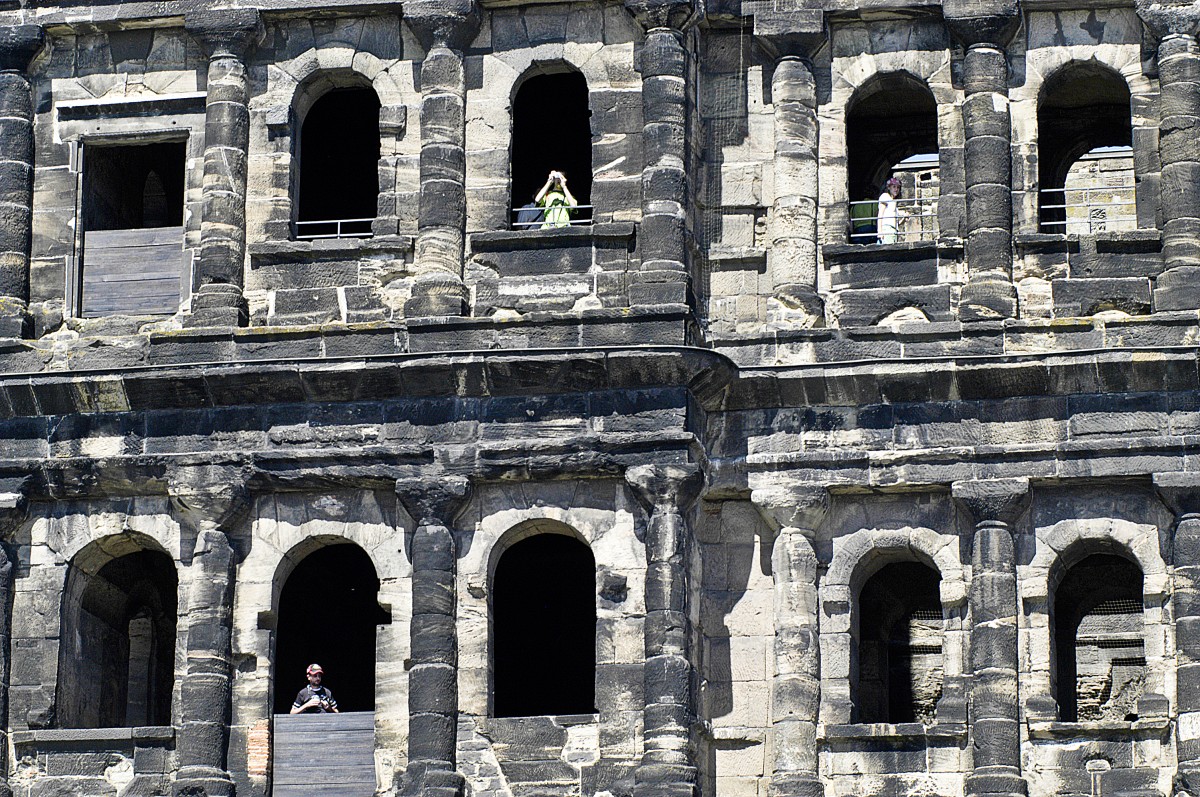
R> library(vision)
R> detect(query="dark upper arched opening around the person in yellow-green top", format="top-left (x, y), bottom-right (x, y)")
top-left (512, 71), bottom-right (592, 229)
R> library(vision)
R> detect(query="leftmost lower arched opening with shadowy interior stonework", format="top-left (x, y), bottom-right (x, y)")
top-left (58, 544), bottom-right (178, 727)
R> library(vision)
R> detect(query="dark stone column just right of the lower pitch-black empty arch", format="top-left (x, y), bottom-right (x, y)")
top-left (625, 465), bottom-right (702, 797)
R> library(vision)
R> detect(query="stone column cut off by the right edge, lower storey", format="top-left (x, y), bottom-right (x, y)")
top-left (1154, 473), bottom-right (1200, 782)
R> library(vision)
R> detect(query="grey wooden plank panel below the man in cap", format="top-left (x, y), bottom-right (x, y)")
top-left (271, 712), bottom-right (376, 797)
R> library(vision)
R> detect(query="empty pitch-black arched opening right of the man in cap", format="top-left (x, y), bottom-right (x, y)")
top-left (492, 534), bottom-right (596, 717)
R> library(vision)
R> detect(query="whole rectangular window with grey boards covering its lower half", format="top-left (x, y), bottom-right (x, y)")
top-left (78, 142), bottom-right (185, 318)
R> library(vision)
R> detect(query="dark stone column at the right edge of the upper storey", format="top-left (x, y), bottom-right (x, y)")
top-left (1138, 6), bottom-right (1200, 310)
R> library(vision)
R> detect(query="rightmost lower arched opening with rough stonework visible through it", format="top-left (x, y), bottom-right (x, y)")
top-left (1050, 551), bottom-right (1146, 723)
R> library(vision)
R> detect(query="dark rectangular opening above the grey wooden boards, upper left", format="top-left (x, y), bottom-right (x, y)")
top-left (83, 142), bottom-right (186, 232)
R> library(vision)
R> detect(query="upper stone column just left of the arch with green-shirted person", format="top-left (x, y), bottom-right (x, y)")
top-left (404, 0), bottom-right (480, 318)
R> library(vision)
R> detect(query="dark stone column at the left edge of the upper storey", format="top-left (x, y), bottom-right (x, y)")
top-left (0, 25), bottom-right (43, 337)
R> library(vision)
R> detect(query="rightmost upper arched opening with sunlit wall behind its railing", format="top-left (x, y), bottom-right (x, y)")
top-left (1038, 61), bottom-right (1138, 234)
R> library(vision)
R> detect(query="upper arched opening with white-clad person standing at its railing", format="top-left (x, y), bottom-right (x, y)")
top-left (846, 72), bottom-right (938, 244)
